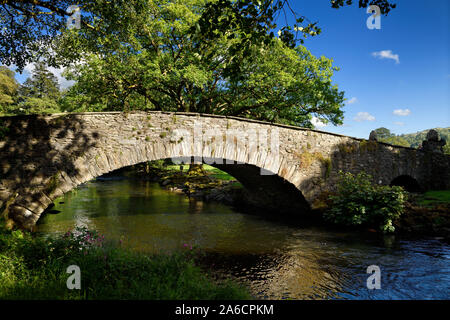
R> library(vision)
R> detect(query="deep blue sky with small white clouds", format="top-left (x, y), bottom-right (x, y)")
top-left (10, 0), bottom-right (450, 138)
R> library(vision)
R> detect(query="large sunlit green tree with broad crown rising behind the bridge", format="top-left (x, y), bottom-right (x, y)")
top-left (61, 0), bottom-right (344, 127)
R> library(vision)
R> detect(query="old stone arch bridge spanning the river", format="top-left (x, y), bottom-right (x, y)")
top-left (0, 112), bottom-right (450, 229)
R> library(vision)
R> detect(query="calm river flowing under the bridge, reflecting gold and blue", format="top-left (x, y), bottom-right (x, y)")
top-left (37, 177), bottom-right (450, 299)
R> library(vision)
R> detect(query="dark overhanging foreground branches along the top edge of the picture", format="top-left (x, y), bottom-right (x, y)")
top-left (0, 0), bottom-right (395, 72)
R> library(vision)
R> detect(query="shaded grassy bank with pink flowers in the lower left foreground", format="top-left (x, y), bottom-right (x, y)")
top-left (0, 222), bottom-right (251, 300)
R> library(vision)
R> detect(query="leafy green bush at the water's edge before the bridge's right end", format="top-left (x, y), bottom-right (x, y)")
top-left (324, 171), bottom-right (406, 232)
